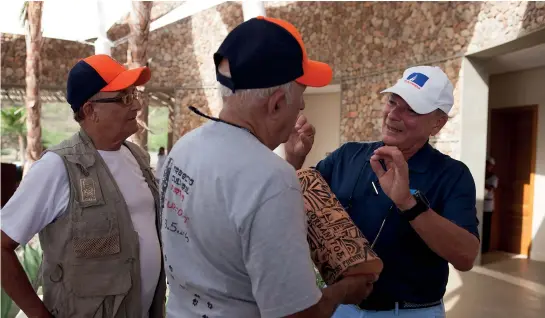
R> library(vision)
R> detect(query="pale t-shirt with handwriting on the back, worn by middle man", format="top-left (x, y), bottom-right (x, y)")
top-left (161, 121), bottom-right (321, 318)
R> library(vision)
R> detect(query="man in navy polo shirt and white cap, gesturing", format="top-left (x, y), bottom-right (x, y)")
top-left (285, 66), bottom-right (479, 318)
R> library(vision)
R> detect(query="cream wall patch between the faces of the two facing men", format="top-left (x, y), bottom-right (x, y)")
top-left (303, 92), bottom-right (341, 167)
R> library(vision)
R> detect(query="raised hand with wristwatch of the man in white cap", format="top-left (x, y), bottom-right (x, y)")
top-left (370, 146), bottom-right (416, 211)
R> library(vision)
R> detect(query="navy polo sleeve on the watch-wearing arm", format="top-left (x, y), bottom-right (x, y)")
top-left (441, 164), bottom-right (479, 238)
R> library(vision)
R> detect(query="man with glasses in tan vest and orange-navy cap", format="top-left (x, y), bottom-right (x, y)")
top-left (1, 55), bottom-right (166, 318)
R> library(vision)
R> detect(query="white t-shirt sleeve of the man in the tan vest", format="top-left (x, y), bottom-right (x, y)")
top-left (1, 152), bottom-right (70, 244)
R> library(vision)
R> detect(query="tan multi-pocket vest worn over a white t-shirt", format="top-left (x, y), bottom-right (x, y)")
top-left (39, 130), bottom-right (166, 318)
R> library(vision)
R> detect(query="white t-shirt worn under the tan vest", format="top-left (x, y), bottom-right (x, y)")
top-left (1, 146), bottom-right (162, 317)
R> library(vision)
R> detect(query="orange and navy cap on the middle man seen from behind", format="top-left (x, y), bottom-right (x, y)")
top-left (214, 16), bottom-right (333, 93)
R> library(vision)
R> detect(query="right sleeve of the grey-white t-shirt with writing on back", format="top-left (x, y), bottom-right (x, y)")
top-left (241, 188), bottom-right (321, 318)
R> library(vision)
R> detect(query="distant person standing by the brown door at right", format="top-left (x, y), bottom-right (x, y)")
top-left (482, 157), bottom-right (499, 253)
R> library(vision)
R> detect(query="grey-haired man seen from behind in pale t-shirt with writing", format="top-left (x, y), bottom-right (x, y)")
top-left (161, 17), bottom-right (374, 318)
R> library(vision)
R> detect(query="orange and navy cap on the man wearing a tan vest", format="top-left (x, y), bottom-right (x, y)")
top-left (66, 54), bottom-right (151, 113)
